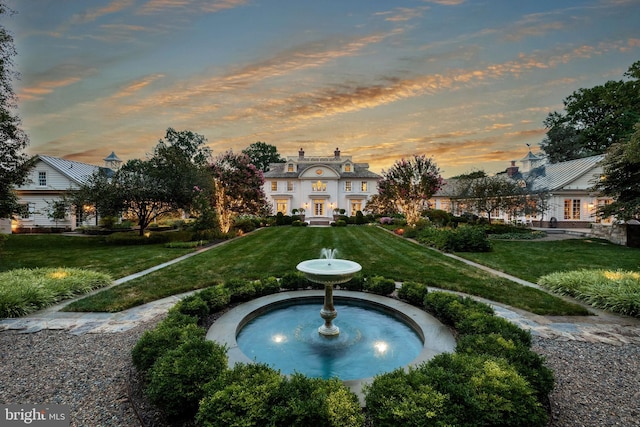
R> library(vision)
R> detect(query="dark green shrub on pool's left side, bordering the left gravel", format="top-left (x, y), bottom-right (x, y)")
top-left (131, 322), bottom-right (206, 375)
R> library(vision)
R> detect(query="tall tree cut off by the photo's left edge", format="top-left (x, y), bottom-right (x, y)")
top-left (0, 1), bottom-right (33, 218)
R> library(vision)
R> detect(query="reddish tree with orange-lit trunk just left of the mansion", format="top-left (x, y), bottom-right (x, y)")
top-left (210, 150), bottom-right (268, 233)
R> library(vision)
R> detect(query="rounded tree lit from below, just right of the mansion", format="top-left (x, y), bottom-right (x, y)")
top-left (378, 155), bottom-right (442, 225)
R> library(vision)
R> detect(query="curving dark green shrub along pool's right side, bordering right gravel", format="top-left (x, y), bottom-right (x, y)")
top-left (456, 333), bottom-right (555, 401)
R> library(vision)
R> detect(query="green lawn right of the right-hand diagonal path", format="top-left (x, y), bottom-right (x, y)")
top-left (456, 239), bottom-right (640, 283)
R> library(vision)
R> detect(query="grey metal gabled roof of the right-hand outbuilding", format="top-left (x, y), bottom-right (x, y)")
top-left (527, 154), bottom-right (605, 191)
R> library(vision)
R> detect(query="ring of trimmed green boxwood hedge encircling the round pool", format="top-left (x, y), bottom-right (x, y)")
top-left (132, 273), bottom-right (554, 427)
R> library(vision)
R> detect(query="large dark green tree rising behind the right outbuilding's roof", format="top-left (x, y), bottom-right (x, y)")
top-left (540, 61), bottom-right (640, 163)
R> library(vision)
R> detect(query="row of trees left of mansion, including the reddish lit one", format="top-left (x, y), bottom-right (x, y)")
top-left (68, 132), bottom-right (275, 235)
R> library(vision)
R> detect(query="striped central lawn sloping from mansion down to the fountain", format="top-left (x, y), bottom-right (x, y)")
top-left (65, 226), bottom-right (585, 315)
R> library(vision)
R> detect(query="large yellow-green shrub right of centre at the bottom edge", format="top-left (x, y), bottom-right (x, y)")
top-left (417, 353), bottom-right (547, 427)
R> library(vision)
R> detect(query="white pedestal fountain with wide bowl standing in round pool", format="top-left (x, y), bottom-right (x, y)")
top-left (296, 248), bottom-right (362, 337)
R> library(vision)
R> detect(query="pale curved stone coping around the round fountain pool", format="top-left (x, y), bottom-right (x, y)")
top-left (206, 290), bottom-right (456, 405)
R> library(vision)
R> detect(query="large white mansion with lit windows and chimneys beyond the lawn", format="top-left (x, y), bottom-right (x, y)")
top-left (264, 148), bottom-right (381, 223)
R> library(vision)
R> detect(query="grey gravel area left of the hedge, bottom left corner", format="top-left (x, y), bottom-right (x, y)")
top-left (0, 323), bottom-right (158, 427)
